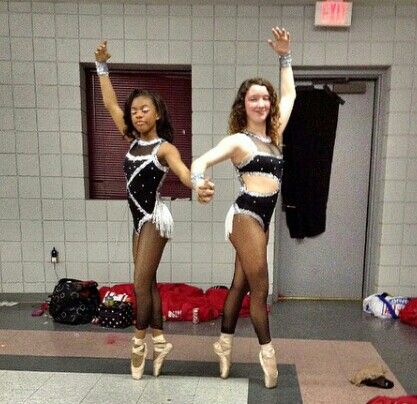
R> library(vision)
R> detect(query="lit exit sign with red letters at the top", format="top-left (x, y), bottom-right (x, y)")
top-left (314, 0), bottom-right (352, 27)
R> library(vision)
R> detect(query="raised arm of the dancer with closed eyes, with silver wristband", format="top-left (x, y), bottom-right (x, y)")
top-left (94, 41), bottom-right (129, 141)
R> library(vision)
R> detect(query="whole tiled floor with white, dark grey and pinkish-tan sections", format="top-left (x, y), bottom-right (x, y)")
top-left (0, 301), bottom-right (417, 404)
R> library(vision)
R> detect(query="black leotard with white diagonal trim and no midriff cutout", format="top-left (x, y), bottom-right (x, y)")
top-left (124, 138), bottom-right (173, 238)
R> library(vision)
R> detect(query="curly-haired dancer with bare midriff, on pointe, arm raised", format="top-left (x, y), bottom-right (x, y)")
top-left (191, 27), bottom-right (295, 388)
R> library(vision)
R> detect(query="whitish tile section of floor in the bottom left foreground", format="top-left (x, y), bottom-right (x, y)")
top-left (0, 371), bottom-right (248, 404)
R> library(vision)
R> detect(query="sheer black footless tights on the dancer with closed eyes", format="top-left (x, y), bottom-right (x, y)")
top-left (133, 222), bottom-right (168, 330)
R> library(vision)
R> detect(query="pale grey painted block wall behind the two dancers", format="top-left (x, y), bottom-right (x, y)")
top-left (0, 0), bottom-right (417, 294)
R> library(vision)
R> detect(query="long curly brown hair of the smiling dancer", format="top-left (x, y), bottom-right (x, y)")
top-left (229, 77), bottom-right (282, 147)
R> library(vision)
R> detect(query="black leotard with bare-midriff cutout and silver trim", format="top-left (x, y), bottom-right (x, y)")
top-left (225, 132), bottom-right (283, 239)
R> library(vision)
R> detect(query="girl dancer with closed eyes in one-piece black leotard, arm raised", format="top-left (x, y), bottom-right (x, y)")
top-left (95, 42), bottom-right (213, 379)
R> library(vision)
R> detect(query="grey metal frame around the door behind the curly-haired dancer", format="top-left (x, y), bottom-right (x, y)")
top-left (272, 67), bottom-right (389, 300)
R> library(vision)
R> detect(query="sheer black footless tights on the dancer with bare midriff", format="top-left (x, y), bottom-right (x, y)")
top-left (222, 214), bottom-right (271, 344)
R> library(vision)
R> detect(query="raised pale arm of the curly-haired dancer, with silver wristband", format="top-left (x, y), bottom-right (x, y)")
top-left (268, 27), bottom-right (296, 135)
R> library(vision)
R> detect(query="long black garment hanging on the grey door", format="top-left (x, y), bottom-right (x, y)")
top-left (282, 86), bottom-right (343, 238)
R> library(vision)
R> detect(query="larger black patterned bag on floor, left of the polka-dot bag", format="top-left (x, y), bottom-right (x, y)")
top-left (49, 278), bottom-right (100, 325)
